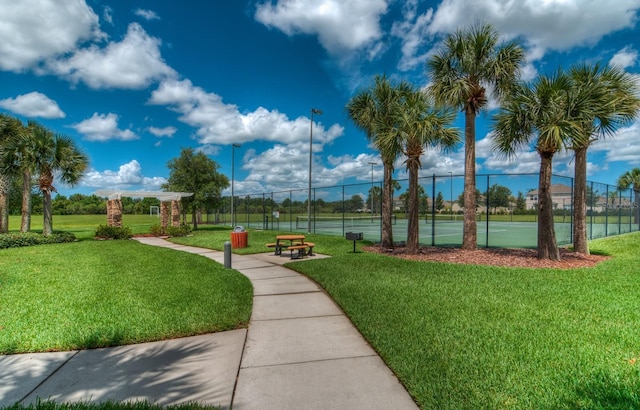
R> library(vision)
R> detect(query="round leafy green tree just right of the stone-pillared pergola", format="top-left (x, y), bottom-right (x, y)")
top-left (162, 148), bottom-right (229, 230)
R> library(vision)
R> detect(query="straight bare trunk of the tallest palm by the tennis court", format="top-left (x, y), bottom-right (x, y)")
top-left (462, 107), bottom-right (477, 250)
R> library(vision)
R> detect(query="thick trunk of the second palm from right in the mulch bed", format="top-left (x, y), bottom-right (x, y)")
top-left (538, 152), bottom-right (560, 261)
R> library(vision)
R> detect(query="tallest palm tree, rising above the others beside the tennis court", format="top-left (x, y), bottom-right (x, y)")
top-left (427, 24), bottom-right (524, 249)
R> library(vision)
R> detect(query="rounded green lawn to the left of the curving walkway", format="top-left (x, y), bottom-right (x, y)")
top-left (0, 240), bottom-right (252, 353)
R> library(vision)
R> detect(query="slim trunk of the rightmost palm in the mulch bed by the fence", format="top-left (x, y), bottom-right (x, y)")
top-left (573, 148), bottom-right (589, 255)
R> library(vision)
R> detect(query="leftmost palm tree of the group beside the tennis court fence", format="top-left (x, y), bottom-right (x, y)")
top-left (346, 76), bottom-right (411, 248)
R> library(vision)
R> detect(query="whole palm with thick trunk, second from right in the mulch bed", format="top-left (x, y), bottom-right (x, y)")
top-left (492, 72), bottom-right (578, 260)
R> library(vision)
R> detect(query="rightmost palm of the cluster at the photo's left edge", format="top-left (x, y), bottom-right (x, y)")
top-left (27, 123), bottom-right (89, 235)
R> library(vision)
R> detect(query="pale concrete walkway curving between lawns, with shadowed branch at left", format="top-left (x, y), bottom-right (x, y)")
top-left (0, 238), bottom-right (417, 410)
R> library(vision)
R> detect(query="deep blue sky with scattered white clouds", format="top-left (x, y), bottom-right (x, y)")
top-left (0, 0), bottom-right (640, 199)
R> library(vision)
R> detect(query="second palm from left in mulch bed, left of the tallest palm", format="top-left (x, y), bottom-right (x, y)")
top-left (382, 88), bottom-right (460, 254)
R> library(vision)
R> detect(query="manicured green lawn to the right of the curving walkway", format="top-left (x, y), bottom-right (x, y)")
top-left (291, 233), bottom-right (640, 409)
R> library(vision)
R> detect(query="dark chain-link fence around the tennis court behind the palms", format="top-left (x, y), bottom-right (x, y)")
top-left (206, 173), bottom-right (640, 248)
